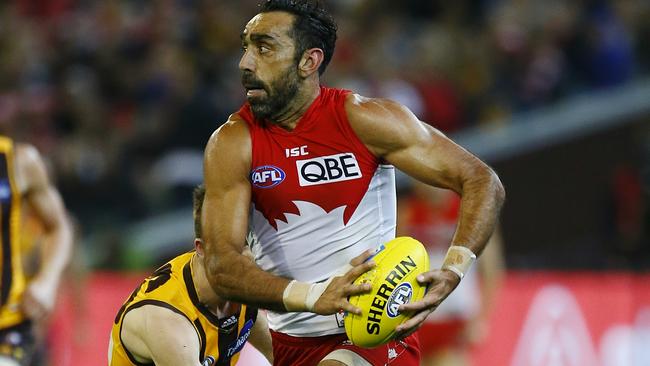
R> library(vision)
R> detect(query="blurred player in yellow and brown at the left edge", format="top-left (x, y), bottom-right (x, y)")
top-left (0, 135), bottom-right (72, 366)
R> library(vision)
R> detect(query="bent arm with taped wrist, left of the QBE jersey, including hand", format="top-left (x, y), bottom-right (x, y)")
top-left (203, 115), bottom-right (374, 315)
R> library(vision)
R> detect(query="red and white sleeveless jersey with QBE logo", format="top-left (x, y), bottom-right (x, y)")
top-left (238, 87), bottom-right (396, 336)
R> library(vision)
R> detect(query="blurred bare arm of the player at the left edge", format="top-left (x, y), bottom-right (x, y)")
top-left (16, 144), bottom-right (72, 321)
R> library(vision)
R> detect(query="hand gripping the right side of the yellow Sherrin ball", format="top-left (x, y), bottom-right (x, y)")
top-left (395, 269), bottom-right (460, 339)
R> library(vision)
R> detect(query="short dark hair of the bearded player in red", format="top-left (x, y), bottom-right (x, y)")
top-left (260, 0), bottom-right (337, 75)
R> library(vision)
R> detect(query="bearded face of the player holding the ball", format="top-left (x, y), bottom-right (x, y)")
top-left (239, 12), bottom-right (301, 119)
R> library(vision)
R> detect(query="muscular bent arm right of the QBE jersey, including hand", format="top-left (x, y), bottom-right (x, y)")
top-left (346, 95), bottom-right (505, 336)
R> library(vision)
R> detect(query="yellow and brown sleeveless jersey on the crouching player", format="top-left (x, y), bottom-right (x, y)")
top-left (108, 252), bottom-right (257, 366)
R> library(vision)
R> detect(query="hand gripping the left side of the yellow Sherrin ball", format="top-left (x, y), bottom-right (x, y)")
top-left (313, 250), bottom-right (376, 315)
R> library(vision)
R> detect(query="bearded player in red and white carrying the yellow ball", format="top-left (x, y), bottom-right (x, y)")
top-left (204, 0), bottom-right (505, 366)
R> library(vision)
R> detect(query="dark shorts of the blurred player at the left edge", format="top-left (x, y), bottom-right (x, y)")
top-left (0, 321), bottom-right (36, 366)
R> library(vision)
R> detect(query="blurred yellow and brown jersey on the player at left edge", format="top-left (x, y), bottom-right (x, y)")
top-left (0, 136), bottom-right (26, 329)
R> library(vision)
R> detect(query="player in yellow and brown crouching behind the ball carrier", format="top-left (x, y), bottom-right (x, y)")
top-left (108, 185), bottom-right (273, 366)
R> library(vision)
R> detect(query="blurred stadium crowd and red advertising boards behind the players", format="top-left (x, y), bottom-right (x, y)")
top-left (0, 0), bottom-right (650, 366)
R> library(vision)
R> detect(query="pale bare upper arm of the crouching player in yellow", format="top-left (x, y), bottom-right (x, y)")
top-left (120, 305), bottom-right (201, 366)
